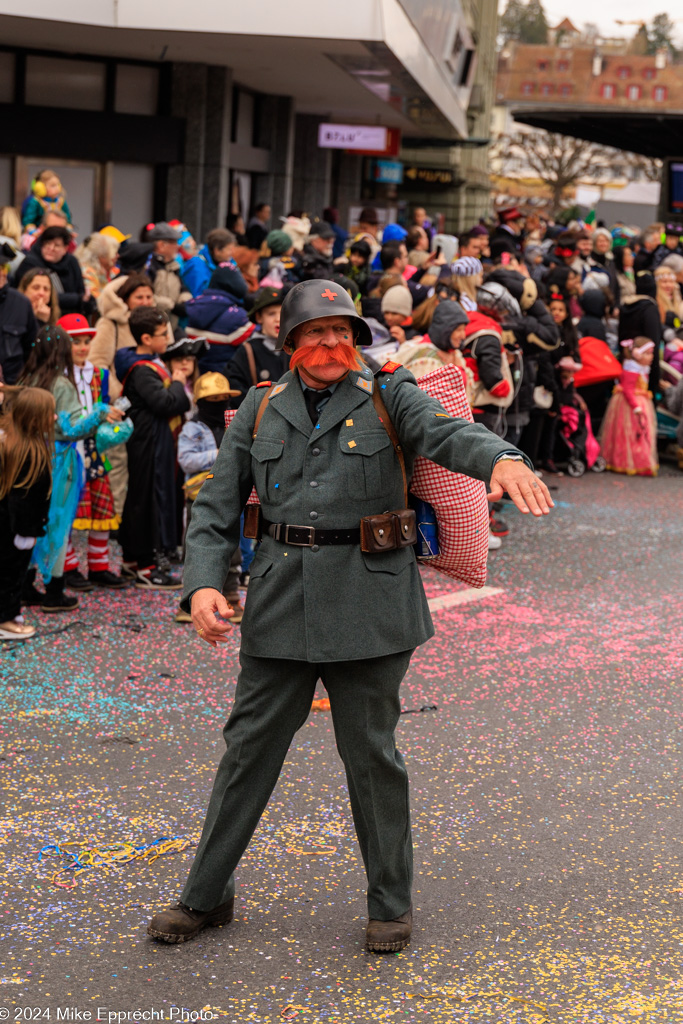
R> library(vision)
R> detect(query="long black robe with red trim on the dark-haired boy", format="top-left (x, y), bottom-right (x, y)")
top-left (114, 348), bottom-right (189, 560)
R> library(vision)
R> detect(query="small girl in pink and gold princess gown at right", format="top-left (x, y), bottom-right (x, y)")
top-left (600, 337), bottom-right (659, 476)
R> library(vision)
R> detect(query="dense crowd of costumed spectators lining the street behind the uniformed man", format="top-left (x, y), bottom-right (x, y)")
top-left (0, 181), bottom-right (683, 634)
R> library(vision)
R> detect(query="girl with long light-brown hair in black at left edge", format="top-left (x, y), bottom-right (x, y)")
top-left (0, 387), bottom-right (54, 640)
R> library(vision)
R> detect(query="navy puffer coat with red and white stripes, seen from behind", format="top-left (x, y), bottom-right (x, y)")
top-left (185, 288), bottom-right (254, 374)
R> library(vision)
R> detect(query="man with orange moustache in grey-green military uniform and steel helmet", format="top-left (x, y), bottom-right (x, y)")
top-left (147, 281), bottom-right (553, 952)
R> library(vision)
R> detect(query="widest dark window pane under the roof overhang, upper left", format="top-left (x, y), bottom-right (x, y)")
top-left (26, 56), bottom-right (105, 111)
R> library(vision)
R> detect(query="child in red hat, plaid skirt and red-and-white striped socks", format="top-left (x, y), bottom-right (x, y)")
top-left (57, 313), bottom-right (127, 591)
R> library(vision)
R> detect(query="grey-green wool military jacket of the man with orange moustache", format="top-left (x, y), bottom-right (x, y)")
top-left (183, 367), bottom-right (516, 662)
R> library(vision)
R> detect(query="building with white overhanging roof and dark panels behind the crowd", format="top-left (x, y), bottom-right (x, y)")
top-left (0, 0), bottom-right (495, 238)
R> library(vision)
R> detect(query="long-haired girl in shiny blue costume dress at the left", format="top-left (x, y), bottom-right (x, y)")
top-left (19, 326), bottom-right (122, 611)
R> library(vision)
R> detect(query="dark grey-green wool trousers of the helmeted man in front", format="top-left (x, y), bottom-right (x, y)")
top-left (181, 650), bottom-right (413, 921)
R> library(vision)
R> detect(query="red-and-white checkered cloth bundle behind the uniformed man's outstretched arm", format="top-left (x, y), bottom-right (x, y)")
top-left (411, 366), bottom-right (488, 587)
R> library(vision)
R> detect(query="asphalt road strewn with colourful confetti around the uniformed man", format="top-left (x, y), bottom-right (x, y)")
top-left (0, 470), bottom-right (683, 1024)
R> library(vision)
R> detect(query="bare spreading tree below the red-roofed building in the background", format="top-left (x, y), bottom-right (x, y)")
top-left (490, 130), bottom-right (657, 213)
